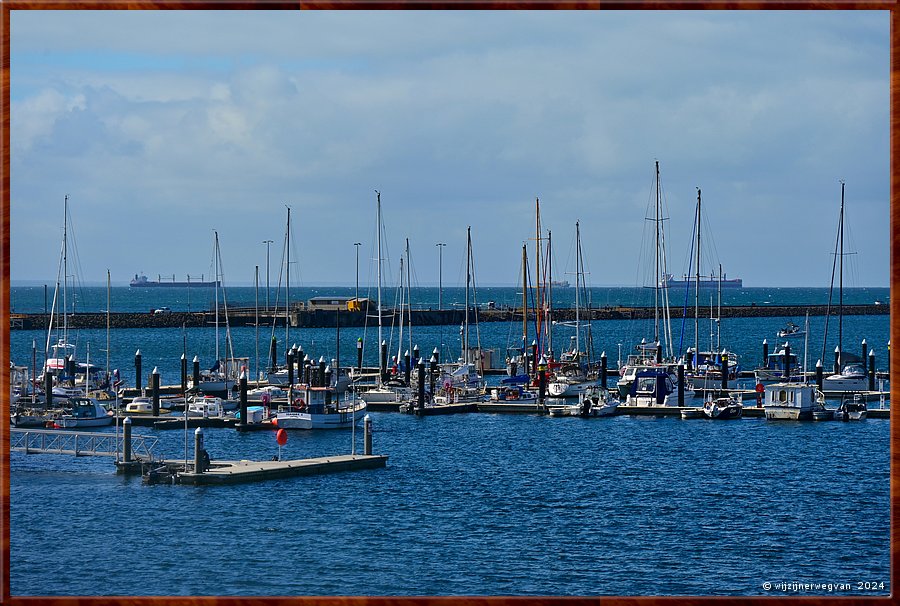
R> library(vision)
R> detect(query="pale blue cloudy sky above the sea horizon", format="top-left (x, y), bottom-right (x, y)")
top-left (10, 11), bottom-right (890, 287)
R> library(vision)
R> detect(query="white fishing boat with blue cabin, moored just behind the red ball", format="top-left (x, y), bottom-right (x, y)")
top-left (272, 384), bottom-right (366, 429)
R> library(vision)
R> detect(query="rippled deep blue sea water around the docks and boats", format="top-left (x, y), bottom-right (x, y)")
top-left (10, 288), bottom-right (890, 596)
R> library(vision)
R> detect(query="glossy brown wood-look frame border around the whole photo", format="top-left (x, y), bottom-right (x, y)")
top-left (0, 0), bottom-right (900, 606)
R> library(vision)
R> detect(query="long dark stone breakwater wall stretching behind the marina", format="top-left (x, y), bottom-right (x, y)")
top-left (9, 304), bottom-right (890, 330)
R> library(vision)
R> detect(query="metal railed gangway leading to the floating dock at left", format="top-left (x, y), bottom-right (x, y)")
top-left (9, 428), bottom-right (158, 460)
